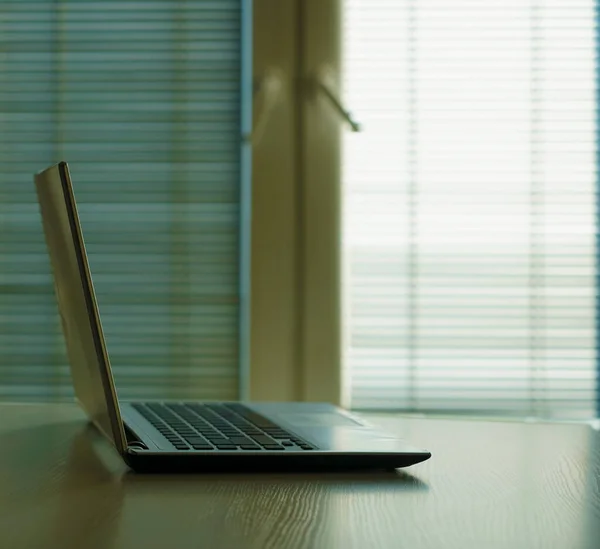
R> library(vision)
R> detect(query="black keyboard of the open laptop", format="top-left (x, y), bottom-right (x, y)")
top-left (132, 402), bottom-right (316, 451)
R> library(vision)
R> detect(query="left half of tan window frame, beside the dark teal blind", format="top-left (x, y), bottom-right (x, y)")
top-left (249, 0), bottom-right (304, 401)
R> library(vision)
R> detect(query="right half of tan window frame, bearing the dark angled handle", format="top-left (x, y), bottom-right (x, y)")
top-left (297, 0), bottom-right (345, 404)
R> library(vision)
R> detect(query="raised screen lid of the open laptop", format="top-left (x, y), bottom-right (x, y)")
top-left (34, 162), bottom-right (127, 453)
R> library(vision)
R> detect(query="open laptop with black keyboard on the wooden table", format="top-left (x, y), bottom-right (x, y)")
top-left (35, 162), bottom-right (431, 472)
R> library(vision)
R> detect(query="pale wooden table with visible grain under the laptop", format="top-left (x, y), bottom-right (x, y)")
top-left (0, 405), bottom-right (600, 549)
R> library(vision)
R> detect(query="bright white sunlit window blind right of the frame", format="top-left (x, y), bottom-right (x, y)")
top-left (343, 0), bottom-right (598, 418)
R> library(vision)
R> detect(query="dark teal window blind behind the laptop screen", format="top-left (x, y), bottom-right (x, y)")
top-left (0, 0), bottom-right (244, 400)
